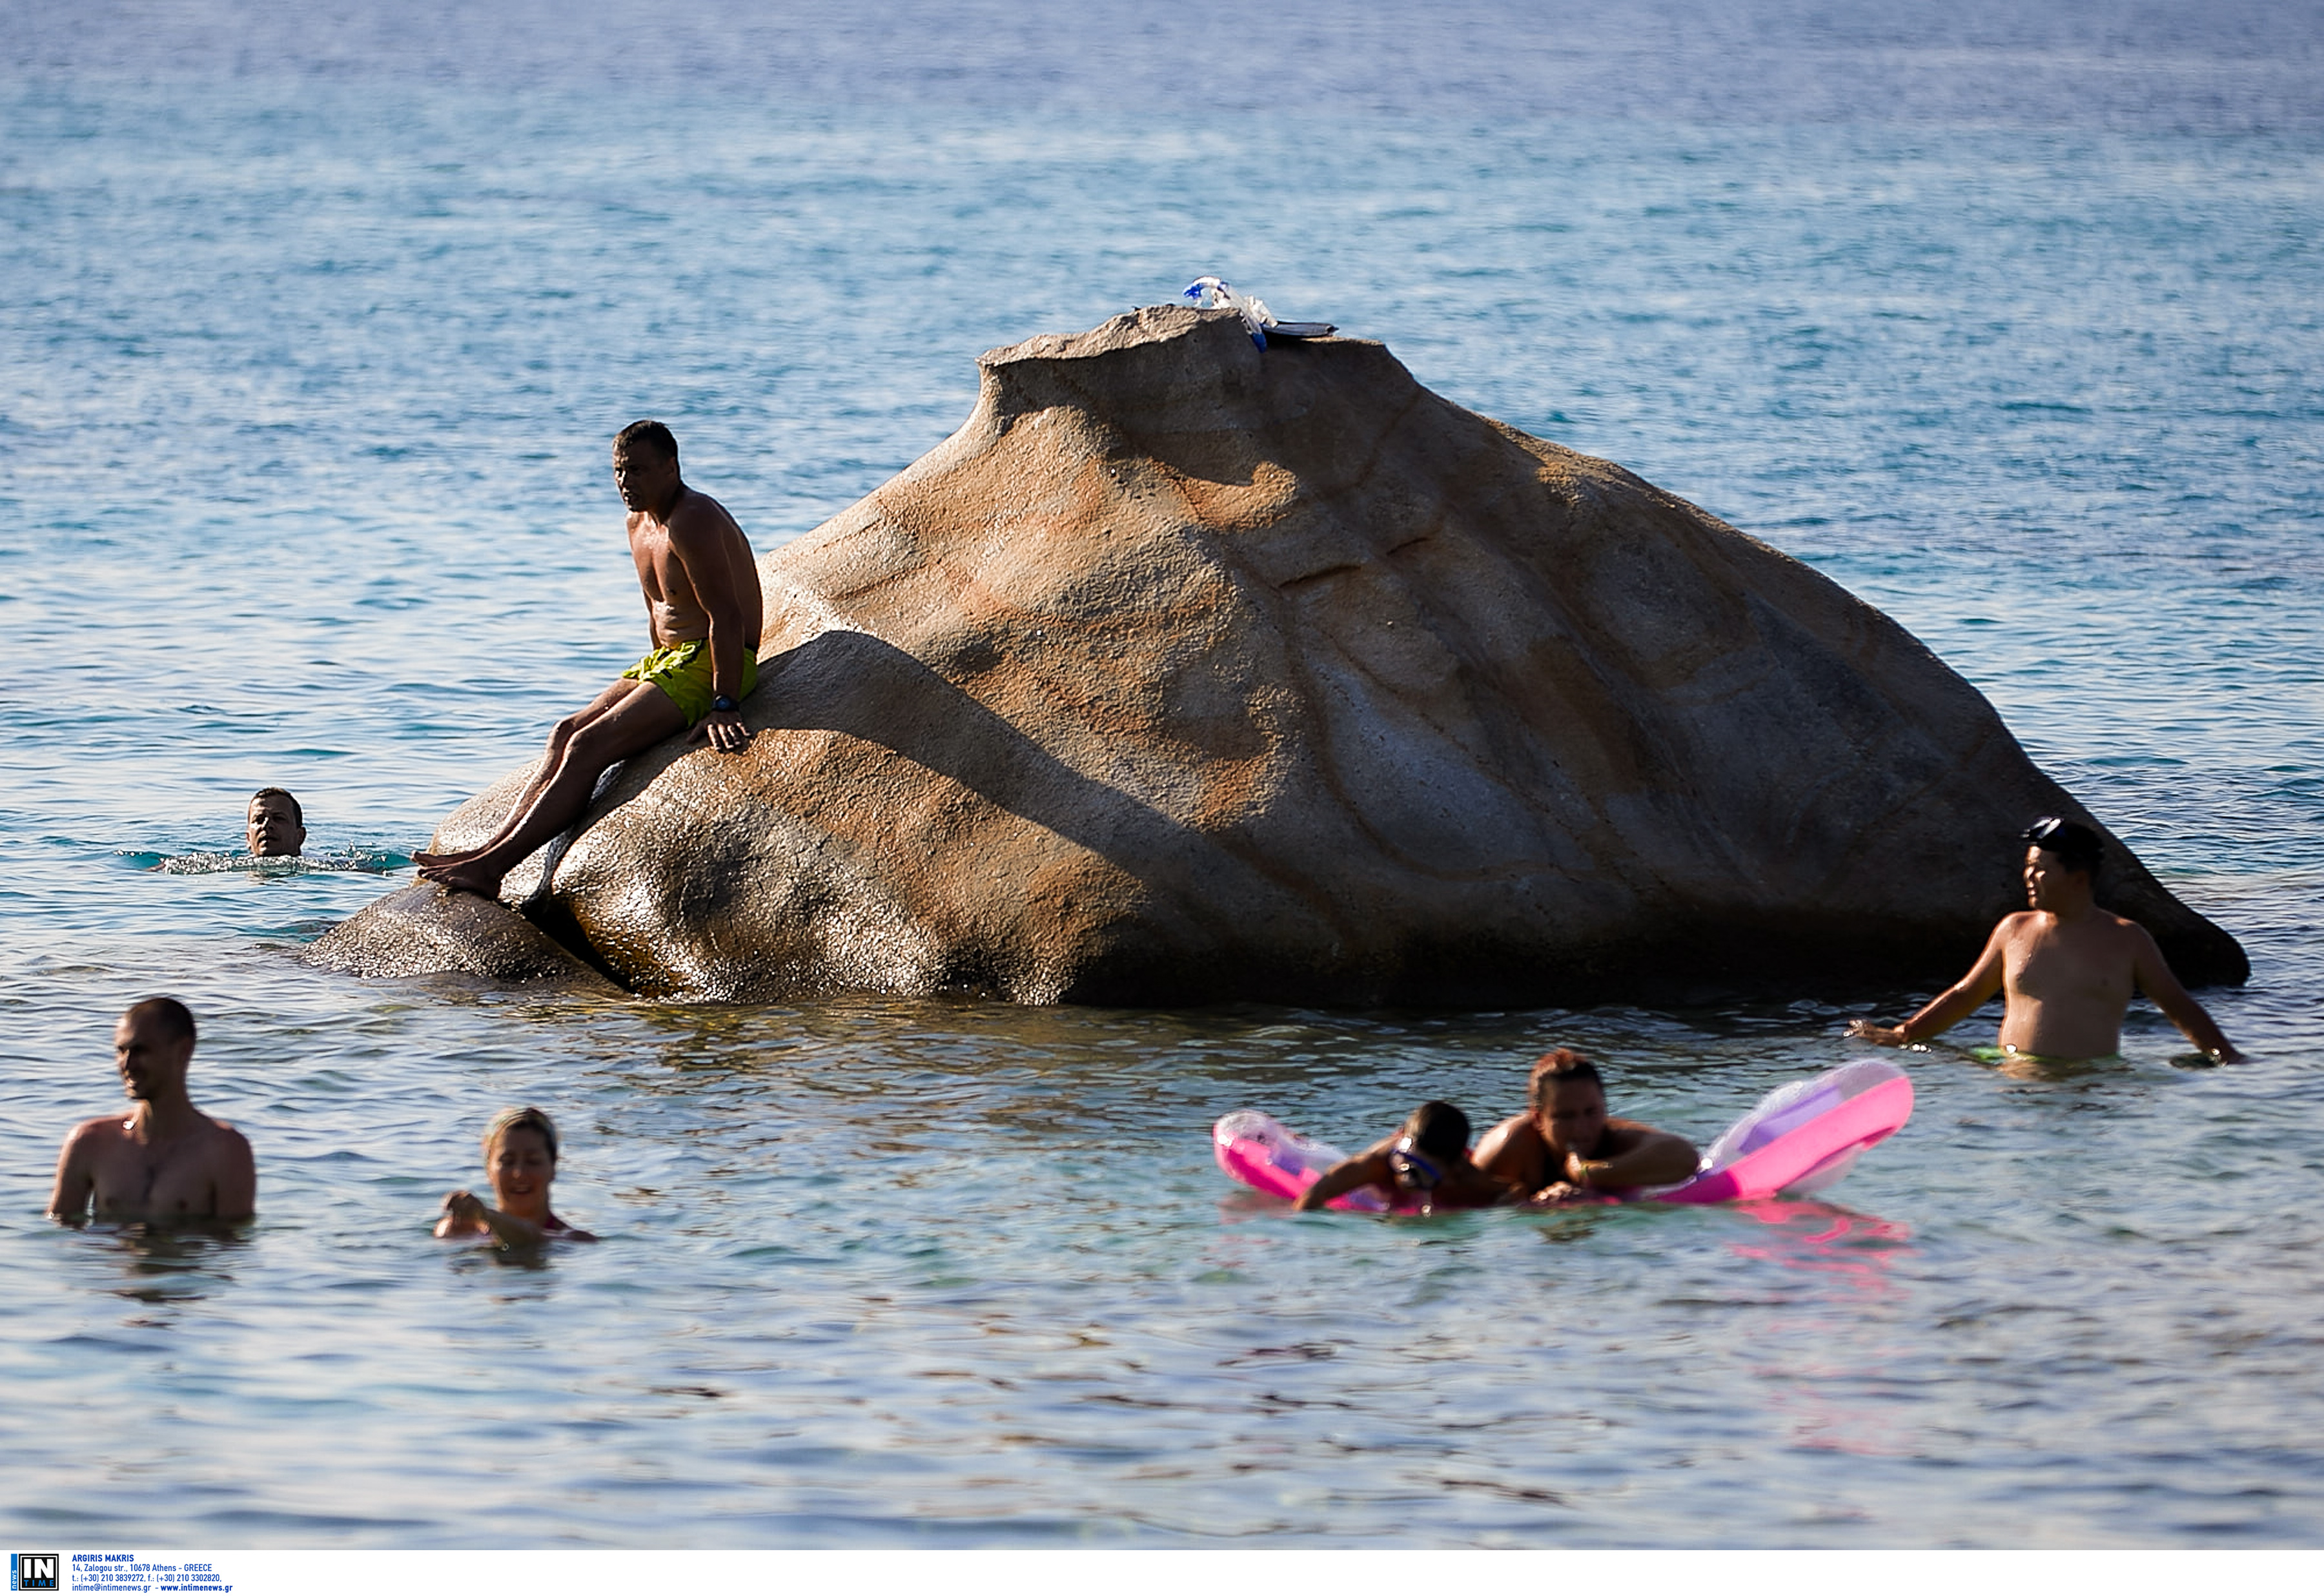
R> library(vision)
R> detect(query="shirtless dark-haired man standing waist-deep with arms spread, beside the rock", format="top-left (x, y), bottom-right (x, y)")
top-left (1848, 820), bottom-right (2243, 1064)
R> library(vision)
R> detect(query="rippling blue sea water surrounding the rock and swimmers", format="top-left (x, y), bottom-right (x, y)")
top-left (0, 0), bottom-right (2324, 1547)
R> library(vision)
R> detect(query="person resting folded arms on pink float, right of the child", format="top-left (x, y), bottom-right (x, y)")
top-left (1476, 1048), bottom-right (1701, 1203)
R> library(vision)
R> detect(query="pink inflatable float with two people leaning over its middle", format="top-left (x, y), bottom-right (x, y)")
top-left (1211, 1059), bottom-right (1913, 1212)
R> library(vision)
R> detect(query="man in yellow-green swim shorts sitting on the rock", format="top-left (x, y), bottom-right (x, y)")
top-left (414, 420), bottom-right (764, 897)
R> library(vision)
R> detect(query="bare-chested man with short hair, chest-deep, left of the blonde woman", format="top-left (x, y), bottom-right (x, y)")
top-left (49, 997), bottom-right (258, 1224)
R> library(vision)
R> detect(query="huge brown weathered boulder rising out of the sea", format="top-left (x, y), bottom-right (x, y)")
top-left (339, 309), bottom-right (2245, 1006)
